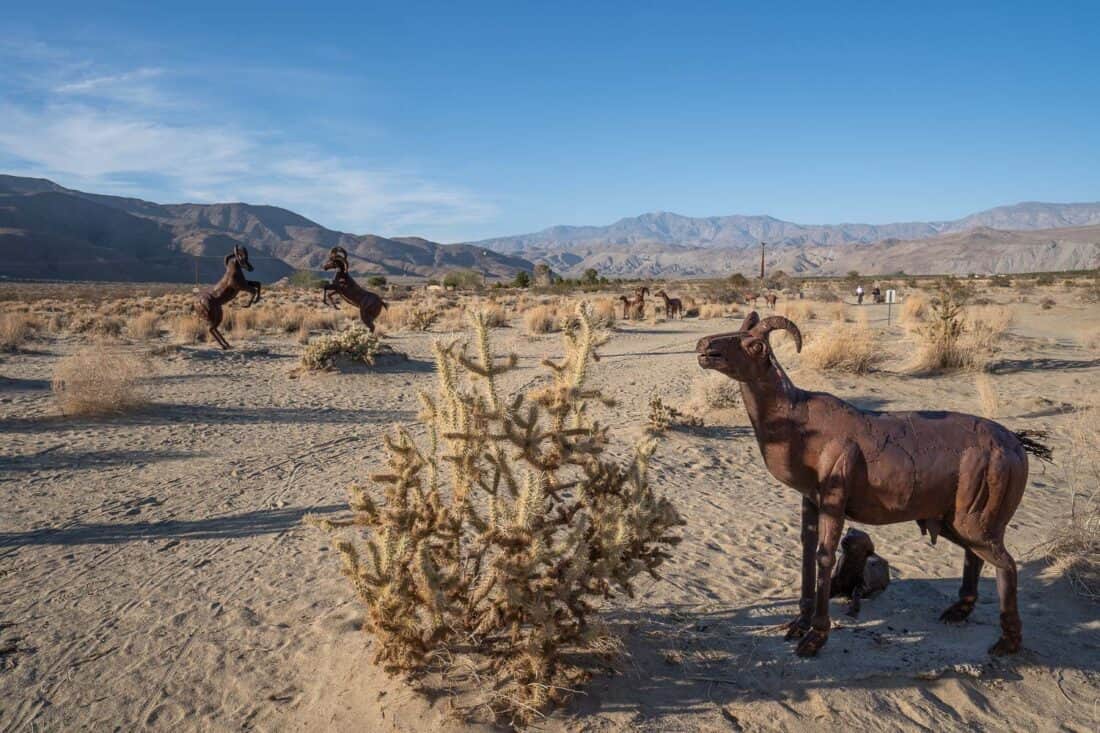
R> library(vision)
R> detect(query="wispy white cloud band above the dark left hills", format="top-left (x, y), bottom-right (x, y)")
top-left (0, 47), bottom-right (496, 238)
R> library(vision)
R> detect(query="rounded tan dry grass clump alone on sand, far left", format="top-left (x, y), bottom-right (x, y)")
top-left (53, 347), bottom-right (150, 415)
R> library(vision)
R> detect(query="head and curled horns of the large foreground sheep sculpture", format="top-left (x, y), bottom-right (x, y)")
top-left (695, 311), bottom-right (802, 382)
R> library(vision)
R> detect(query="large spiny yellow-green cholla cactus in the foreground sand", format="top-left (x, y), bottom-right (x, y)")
top-left (317, 306), bottom-right (683, 723)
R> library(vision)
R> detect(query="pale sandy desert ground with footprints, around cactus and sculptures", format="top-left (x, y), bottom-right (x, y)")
top-left (0, 281), bottom-right (1100, 732)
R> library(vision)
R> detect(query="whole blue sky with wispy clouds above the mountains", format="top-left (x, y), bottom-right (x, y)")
top-left (0, 0), bottom-right (1100, 241)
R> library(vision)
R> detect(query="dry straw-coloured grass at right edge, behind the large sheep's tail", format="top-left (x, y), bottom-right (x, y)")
top-left (1045, 405), bottom-right (1100, 601)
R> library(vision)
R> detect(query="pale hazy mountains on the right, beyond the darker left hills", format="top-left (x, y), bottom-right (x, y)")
top-left (472, 201), bottom-right (1100, 277)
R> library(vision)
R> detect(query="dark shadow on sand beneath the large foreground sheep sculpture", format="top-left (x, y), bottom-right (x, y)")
top-left (571, 561), bottom-right (1100, 730)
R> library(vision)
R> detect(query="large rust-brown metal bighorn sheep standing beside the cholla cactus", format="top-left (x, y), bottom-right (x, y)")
top-left (695, 311), bottom-right (1049, 656)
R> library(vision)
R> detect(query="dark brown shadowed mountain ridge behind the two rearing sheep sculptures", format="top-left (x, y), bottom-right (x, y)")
top-left (0, 175), bottom-right (532, 282)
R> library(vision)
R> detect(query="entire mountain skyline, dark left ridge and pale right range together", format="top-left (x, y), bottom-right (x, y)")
top-left (0, 175), bottom-right (1100, 282)
